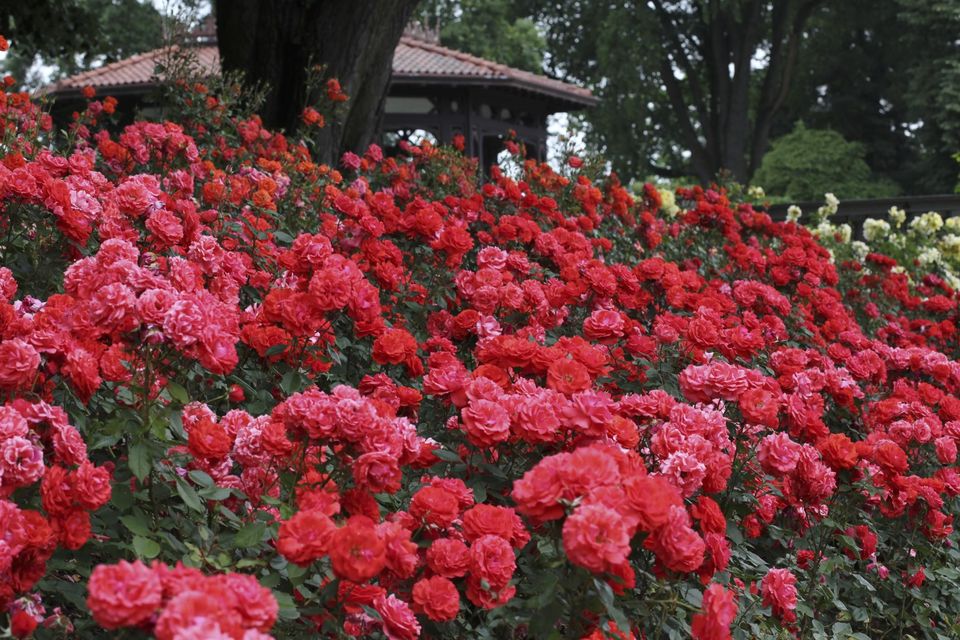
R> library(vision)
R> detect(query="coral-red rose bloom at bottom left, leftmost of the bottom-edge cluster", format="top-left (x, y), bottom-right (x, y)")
top-left (87, 560), bottom-right (163, 629)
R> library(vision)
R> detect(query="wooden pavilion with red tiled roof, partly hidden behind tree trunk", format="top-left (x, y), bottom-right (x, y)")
top-left (46, 29), bottom-right (597, 167)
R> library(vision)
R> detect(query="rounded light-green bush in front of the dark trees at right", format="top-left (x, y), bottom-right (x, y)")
top-left (753, 122), bottom-right (898, 201)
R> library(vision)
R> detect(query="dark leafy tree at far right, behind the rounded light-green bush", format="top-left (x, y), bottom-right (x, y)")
top-left (774, 0), bottom-right (960, 193)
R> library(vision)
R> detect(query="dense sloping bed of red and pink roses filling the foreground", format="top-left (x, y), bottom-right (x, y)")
top-left (0, 40), bottom-right (960, 640)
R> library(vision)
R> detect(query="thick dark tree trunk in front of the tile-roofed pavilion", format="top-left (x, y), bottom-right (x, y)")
top-left (216, 0), bottom-right (419, 162)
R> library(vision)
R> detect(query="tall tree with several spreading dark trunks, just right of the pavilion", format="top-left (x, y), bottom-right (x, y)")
top-left (530, 0), bottom-right (826, 182)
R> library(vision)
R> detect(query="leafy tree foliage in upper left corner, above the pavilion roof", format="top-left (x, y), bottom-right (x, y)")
top-left (0, 0), bottom-right (163, 88)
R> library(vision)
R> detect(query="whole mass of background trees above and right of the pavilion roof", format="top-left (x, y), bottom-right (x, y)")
top-left (444, 0), bottom-right (960, 193)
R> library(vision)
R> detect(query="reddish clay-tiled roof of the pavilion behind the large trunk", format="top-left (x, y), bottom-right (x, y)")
top-left (47, 36), bottom-right (596, 106)
